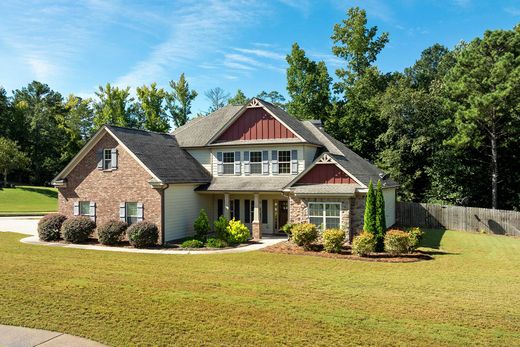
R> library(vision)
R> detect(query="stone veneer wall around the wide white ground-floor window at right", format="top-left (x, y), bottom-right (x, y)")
top-left (289, 195), bottom-right (365, 240)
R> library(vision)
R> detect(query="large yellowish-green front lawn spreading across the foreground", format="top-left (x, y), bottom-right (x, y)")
top-left (0, 231), bottom-right (520, 346)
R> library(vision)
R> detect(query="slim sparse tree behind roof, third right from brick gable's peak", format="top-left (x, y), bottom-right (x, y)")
top-left (166, 73), bottom-right (198, 127)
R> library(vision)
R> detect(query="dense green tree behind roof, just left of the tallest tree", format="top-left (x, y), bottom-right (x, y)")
top-left (286, 43), bottom-right (332, 120)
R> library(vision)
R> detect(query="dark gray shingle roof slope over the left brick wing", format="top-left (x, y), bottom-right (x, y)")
top-left (106, 125), bottom-right (211, 183)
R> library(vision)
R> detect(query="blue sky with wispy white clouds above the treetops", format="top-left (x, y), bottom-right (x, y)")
top-left (0, 0), bottom-right (520, 113)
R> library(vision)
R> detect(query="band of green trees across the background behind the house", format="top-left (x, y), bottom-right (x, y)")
top-left (0, 7), bottom-right (520, 209)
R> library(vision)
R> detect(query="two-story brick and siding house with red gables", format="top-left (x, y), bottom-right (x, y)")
top-left (53, 98), bottom-right (397, 242)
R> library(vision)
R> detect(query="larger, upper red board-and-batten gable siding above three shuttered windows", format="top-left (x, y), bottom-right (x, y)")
top-left (216, 108), bottom-right (296, 142)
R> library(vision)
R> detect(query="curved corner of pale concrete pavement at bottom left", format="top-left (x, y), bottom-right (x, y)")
top-left (0, 324), bottom-right (105, 347)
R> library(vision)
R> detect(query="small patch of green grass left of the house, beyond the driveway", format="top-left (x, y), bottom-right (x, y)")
top-left (0, 186), bottom-right (58, 215)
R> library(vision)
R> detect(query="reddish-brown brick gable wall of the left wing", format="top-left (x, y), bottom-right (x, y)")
top-left (58, 134), bottom-right (162, 245)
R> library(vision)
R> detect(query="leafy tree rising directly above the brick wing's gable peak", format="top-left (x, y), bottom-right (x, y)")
top-left (94, 83), bottom-right (138, 129)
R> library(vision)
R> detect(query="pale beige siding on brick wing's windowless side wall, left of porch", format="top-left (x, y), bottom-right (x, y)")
top-left (164, 184), bottom-right (212, 241)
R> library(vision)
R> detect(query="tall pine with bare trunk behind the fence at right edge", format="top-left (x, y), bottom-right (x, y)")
top-left (445, 29), bottom-right (520, 208)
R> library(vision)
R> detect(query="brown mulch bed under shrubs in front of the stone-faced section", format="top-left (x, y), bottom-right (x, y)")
top-left (262, 241), bottom-right (433, 263)
